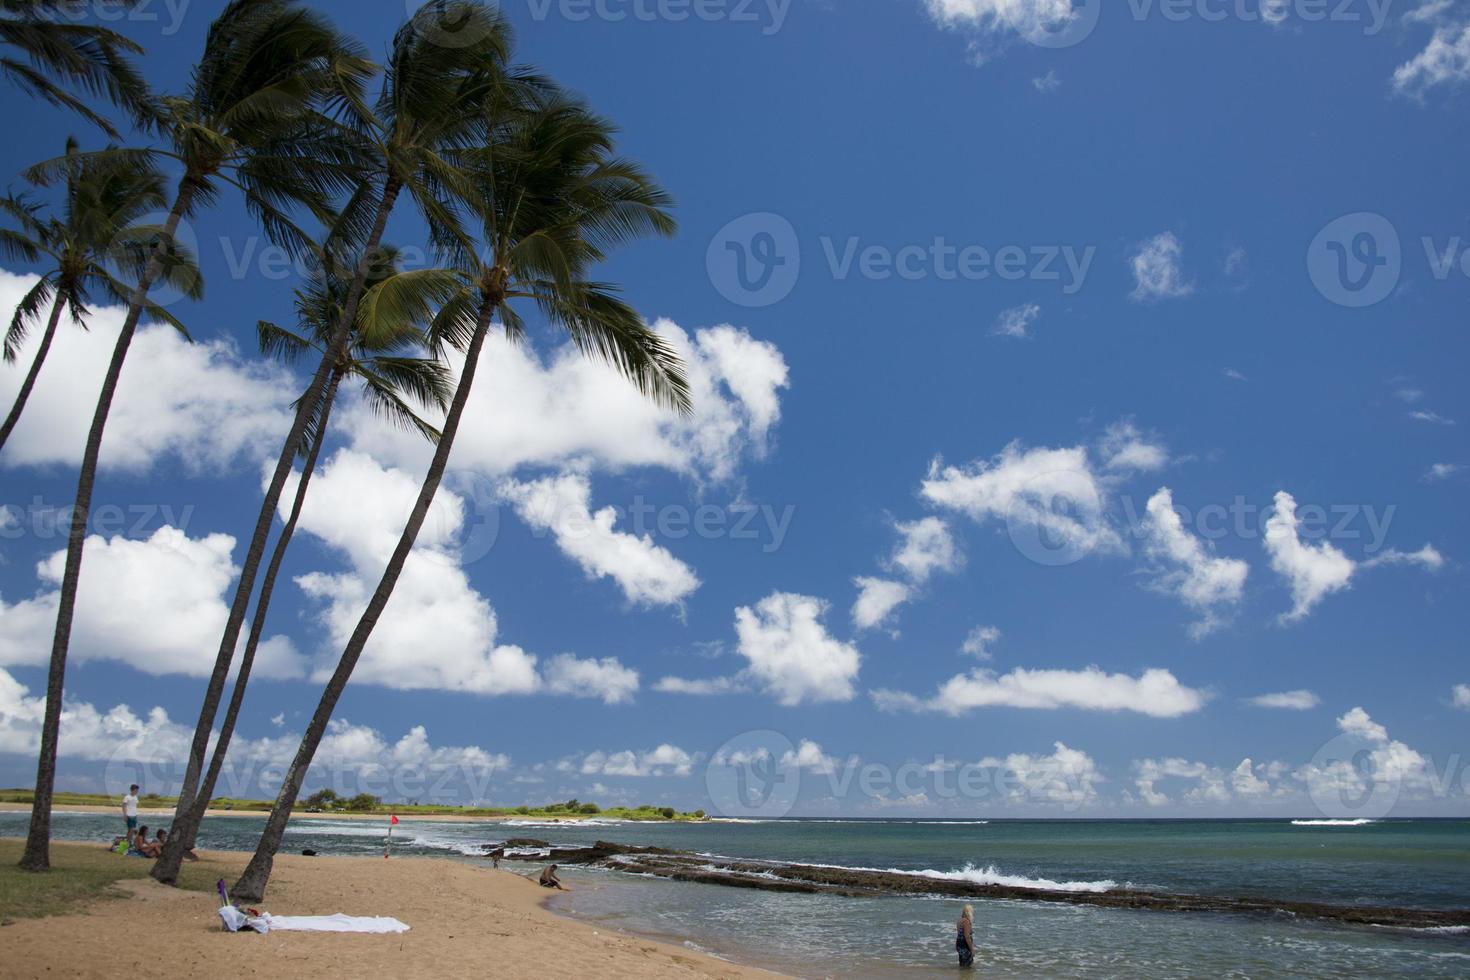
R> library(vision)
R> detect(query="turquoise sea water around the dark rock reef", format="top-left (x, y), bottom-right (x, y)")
top-left (0, 814), bottom-right (1470, 977)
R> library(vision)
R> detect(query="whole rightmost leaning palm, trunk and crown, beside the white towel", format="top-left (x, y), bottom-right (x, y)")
top-left (231, 93), bottom-right (689, 901)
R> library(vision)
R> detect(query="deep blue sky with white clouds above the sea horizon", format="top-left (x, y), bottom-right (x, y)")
top-left (0, 0), bottom-right (1470, 815)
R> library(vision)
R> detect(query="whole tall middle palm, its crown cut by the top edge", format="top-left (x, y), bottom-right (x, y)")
top-left (153, 0), bottom-right (537, 883)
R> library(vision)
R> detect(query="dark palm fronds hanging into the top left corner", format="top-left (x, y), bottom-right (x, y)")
top-left (0, 0), bottom-right (156, 140)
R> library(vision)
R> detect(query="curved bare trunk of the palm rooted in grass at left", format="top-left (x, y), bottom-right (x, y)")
top-left (21, 176), bottom-right (196, 871)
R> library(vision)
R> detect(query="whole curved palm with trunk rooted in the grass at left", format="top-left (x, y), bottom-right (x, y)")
top-left (21, 0), bottom-right (370, 871)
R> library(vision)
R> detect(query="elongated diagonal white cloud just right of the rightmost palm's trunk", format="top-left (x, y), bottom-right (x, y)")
top-left (500, 473), bottom-right (700, 605)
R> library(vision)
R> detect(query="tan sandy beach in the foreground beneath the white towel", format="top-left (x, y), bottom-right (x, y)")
top-left (0, 842), bottom-right (775, 979)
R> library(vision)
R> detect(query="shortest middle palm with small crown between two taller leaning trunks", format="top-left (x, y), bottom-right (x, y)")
top-left (164, 248), bottom-right (453, 874)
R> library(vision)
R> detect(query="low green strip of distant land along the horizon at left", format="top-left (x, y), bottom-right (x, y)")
top-left (0, 789), bottom-right (709, 823)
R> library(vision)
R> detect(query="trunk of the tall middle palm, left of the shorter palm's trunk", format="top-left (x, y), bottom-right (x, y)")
top-left (151, 178), bottom-right (401, 884)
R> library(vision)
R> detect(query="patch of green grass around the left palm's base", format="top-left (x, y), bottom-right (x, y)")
top-left (0, 839), bottom-right (226, 926)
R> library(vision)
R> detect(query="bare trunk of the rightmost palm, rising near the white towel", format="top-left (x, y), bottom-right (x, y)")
top-left (229, 301), bottom-right (495, 902)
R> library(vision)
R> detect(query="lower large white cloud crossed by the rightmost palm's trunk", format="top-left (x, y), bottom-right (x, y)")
top-left (297, 451), bottom-right (638, 704)
